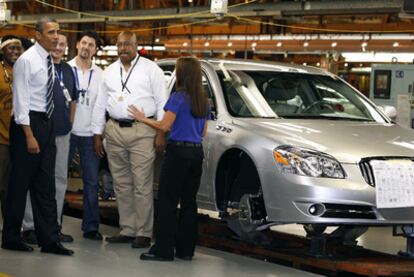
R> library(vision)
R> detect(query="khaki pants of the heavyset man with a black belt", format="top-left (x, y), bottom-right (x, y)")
top-left (105, 120), bottom-right (156, 237)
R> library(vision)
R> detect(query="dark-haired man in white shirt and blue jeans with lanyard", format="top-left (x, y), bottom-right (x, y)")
top-left (68, 31), bottom-right (102, 240)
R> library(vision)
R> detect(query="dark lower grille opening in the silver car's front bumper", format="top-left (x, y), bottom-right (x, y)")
top-left (321, 203), bottom-right (377, 219)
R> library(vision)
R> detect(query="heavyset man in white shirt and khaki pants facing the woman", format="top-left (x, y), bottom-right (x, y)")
top-left (92, 31), bottom-right (167, 248)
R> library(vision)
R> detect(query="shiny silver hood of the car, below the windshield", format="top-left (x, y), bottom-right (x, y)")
top-left (233, 119), bottom-right (414, 163)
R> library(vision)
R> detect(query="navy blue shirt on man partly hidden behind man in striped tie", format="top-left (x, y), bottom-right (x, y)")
top-left (52, 62), bottom-right (78, 136)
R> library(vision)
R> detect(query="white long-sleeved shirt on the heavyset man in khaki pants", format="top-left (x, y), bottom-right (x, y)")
top-left (92, 55), bottom-right (167, 134)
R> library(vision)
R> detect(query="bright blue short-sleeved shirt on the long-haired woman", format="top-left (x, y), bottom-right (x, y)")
top-left (164, 92), bottom-right (207, 143)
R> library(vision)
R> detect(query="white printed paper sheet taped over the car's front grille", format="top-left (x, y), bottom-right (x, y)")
top-left (370, 160), bottom-right (414, 208)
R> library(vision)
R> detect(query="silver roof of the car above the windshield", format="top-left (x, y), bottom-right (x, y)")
top-left (158, 58), bottom-right (333, 76)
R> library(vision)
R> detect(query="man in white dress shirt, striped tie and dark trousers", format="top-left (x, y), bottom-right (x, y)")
top-left (2, 17), bottom-right (73, 255)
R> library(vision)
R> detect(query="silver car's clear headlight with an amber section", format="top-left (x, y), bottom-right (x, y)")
top-left (273, 145), bottom-right (345, 179)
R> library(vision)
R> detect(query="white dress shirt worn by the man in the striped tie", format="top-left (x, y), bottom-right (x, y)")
top-left (13, 42), bottom-right (49, 125)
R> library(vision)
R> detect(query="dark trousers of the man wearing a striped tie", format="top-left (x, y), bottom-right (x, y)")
top-left (2, 112), bottom-right (58, 246)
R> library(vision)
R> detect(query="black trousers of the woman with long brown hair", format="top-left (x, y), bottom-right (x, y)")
top-left (150, 145), bottom-right (204, 258)
